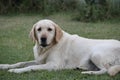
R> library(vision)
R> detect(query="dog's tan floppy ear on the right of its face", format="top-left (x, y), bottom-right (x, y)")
top-left (53, 23), bottom-right (63, 42)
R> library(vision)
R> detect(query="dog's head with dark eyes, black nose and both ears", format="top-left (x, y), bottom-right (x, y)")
top-left (30, 19), bottom-right (63, 47)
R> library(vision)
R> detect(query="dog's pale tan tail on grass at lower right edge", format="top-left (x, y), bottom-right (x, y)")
top-left (108, 65), bottom-right (120, 76)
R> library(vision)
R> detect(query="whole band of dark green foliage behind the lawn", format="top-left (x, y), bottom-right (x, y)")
top-left (0, 0), bottom-right (120, 21)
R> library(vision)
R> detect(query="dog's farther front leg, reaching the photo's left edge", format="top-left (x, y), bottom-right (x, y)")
top-left (0, 61), bottom-right (37, 69)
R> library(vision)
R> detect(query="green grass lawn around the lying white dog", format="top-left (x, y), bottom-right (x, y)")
top-left (0, 13), bottom-right (120, 80)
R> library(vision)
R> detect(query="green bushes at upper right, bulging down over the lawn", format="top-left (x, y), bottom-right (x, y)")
top-left (74, 0), bottom-right (120, 22)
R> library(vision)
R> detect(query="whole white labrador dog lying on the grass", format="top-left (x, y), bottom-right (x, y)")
top-left (0, 20), bottom-right (120, 76)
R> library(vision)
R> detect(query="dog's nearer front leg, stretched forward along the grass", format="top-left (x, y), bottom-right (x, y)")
top-left (8, 63), bottom-right (57, 73)
